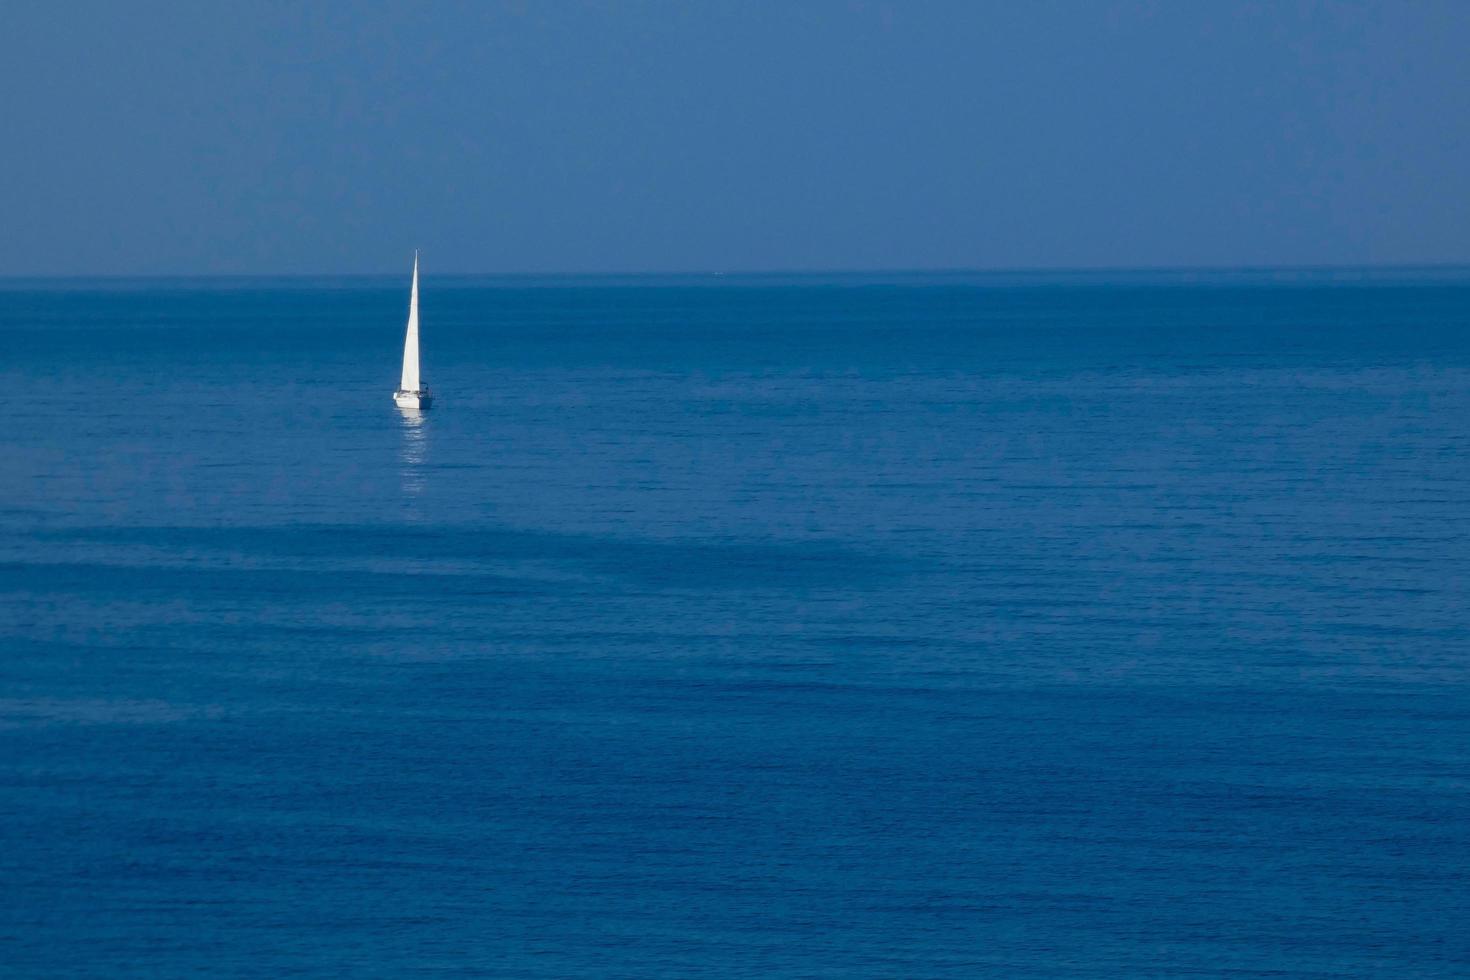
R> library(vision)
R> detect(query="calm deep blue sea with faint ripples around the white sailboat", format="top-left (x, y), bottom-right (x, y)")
top-left (0, 267), bottom-right (1470, 979)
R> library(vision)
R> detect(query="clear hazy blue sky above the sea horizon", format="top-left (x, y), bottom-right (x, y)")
top-left (0, 0), bottom-right (1470, 276)
